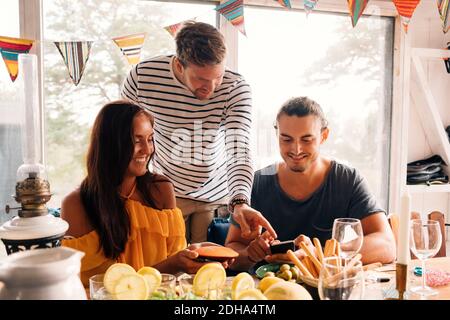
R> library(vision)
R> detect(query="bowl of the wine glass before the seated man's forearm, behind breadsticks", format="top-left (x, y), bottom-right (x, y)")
top-left (332, 218), bottom-right (363, 259)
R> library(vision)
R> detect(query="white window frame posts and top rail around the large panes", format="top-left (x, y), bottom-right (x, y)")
top-left (19, 0), bottom-right (404, 212)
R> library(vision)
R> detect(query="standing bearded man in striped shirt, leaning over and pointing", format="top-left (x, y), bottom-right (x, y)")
top-left (122, 22), bottom-right (275, 243)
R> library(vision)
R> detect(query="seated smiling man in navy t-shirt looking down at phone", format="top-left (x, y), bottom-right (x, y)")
top-left (226, 97), bottom-right (396, 270)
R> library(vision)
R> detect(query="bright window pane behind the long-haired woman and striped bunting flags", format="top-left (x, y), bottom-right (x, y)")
top-left (44, 0), bottom-right (216, 207)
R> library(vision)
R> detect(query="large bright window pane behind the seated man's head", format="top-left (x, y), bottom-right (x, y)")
top-left (239, 7), bottom-right (394, 208)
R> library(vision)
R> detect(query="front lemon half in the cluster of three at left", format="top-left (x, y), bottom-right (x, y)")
top-left (112, 273), bottom-right (149, 300)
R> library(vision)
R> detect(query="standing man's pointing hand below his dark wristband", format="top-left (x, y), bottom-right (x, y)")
top-left (233, 203), bottom-right (277, 239)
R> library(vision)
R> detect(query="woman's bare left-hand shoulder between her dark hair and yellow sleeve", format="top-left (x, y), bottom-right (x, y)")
top-left (61, 188), bottom-right (93, 238)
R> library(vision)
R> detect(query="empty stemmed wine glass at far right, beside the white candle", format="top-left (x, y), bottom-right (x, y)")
top-left (410, 219), bottom-right (442, 297)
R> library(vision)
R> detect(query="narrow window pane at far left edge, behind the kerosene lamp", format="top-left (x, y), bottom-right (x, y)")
top-left (0, 0), bottom-right (23, 224)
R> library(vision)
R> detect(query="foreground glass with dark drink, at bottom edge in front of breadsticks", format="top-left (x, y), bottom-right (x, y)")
top-left (318, 256), bottom-right (365, 300)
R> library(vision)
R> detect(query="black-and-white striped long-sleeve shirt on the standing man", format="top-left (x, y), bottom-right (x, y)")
top-left (122, 56), bottom-right (253, 202)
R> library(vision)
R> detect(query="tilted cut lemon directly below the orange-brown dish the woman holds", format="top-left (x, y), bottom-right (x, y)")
top-left (192, 263), bottom-right (227, 297)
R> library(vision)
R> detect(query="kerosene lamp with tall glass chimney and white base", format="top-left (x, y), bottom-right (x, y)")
top-left (0, 54), bottom-right (69, 254)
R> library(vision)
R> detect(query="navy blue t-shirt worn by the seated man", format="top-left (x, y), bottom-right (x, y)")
top-left (233, 160), bottom-right (385, 244)
